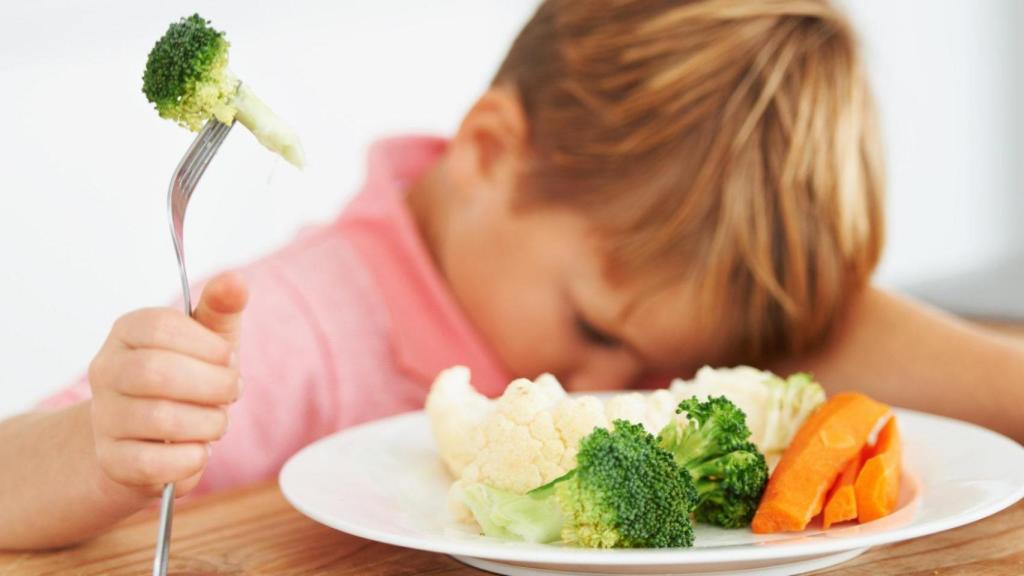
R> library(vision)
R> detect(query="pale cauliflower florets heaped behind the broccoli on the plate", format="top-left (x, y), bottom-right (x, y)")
top-left (426, 366), bottom-right (824, 510)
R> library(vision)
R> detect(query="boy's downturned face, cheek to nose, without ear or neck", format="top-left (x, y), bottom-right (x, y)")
top-left (444, 193), bottom-right (714, 390)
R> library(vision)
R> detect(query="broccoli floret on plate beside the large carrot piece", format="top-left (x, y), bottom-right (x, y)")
top-left (658, 397), bottom-right (768, 528)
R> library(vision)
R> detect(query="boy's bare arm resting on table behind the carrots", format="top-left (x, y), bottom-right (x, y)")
top-left (771, 288), bottom-right (1024, 442)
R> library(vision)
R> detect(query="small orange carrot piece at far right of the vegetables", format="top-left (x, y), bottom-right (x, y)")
top-left (853, 417), bottom-right (903, 523)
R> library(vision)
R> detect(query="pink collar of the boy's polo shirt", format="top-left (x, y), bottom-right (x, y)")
top-left (338, 136), bottom-right (509, 396)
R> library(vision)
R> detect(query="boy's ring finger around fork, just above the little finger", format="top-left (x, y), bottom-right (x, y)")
top-left (93, 394), bottom-right (227, 442)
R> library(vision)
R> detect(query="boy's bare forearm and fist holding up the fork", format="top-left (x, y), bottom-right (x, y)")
top-left (0, 276), bottom-right (247, 549)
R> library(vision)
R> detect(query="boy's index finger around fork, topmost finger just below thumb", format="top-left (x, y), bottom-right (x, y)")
top-left (111, 308), bottom-right (233, 366)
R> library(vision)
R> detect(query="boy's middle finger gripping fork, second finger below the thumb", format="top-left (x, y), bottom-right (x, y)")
top-left (109, 349), bottom-right (242, 406)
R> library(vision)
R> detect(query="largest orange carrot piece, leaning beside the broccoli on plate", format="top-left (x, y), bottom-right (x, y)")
top-left (751, 393), bottom-right (889, 534)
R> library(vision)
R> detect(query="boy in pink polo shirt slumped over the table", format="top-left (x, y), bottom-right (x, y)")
top-left (0, 0), bottom-right (1024, 548)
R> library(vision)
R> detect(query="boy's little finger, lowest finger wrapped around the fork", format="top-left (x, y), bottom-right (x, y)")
top-left (96, 440), bottom-right (209, 488)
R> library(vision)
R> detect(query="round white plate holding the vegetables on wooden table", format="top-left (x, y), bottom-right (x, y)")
top-left (280, 410), bottom-right (1024, 576)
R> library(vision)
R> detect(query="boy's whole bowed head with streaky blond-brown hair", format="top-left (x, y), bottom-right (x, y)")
top-left (411, 0), bottom-right (883, 387)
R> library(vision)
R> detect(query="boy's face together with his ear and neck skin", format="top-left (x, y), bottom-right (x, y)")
top-left (409, 90), bottom-right (718, 390)
